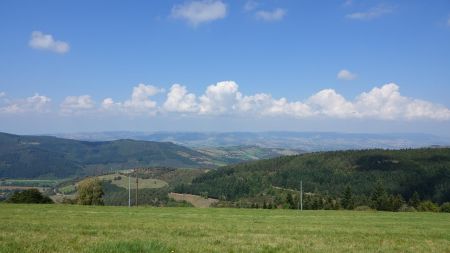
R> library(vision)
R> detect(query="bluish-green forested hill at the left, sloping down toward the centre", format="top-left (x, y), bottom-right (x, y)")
top-left (0, 133), bottom-right (219, 178)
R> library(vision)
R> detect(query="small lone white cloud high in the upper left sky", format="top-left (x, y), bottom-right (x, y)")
top-left (28, 31), bottom-right (70, 54)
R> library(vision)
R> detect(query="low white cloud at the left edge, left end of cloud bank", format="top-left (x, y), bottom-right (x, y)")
top-left (0, 93), bottom-right (51, 114)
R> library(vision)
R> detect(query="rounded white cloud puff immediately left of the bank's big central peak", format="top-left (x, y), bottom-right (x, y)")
top-left (164, 84), bottom-right (198, 112)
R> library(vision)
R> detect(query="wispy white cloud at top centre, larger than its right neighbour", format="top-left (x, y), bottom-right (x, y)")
top-left (170, 0), bottom-right (227, 26)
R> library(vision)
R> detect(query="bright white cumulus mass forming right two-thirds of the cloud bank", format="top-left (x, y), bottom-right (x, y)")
top-left (159, 81), bottom-right (450, 120)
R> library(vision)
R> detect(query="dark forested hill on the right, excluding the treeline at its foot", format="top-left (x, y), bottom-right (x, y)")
top-left (177, 148), bottom-right (450, 203)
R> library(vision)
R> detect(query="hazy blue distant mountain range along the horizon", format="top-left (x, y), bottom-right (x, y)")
top-left (55, 131), bottom-right (450, 151)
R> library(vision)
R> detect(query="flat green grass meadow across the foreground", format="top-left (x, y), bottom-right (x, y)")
top-left (0, 204), bottom-right (450, 252)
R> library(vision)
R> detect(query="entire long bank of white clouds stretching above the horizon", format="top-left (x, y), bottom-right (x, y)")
top-left (0, 81), bottom-right (450, 121)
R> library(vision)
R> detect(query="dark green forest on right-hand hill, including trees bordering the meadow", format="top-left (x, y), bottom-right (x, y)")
top-left (175, 148), bottom-right (450, 210)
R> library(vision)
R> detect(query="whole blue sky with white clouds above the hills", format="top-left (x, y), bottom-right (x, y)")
top-left (0, 0), bottom-right (450, 136)
